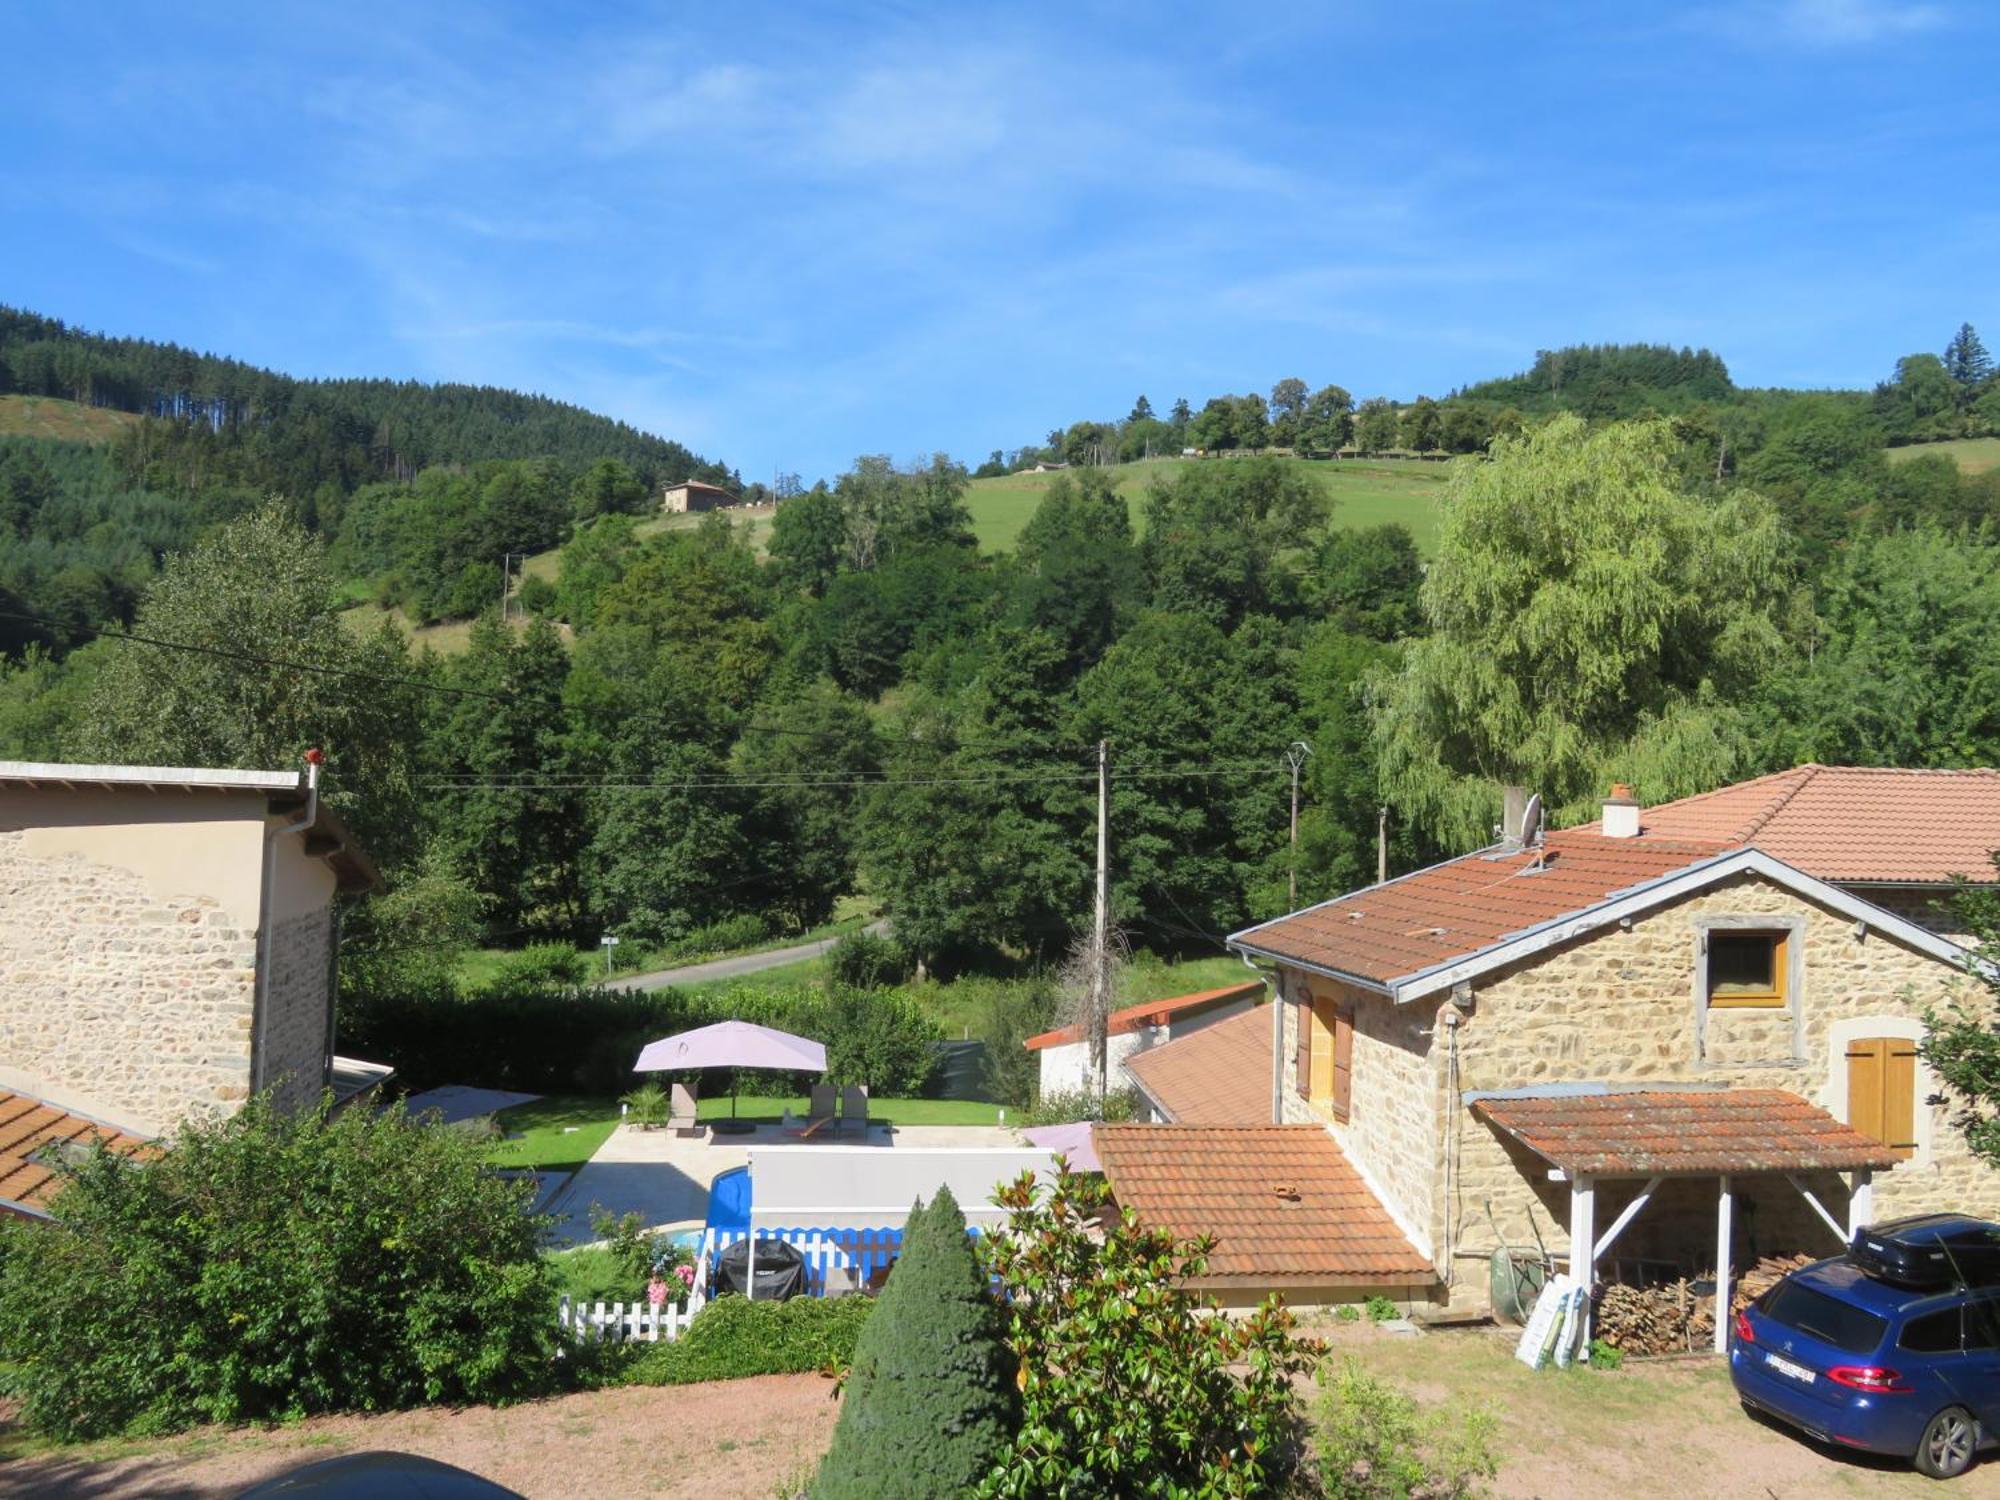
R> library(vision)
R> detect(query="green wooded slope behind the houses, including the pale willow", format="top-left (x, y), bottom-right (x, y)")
top-left (0, 308), bottom-right (2000, 1012)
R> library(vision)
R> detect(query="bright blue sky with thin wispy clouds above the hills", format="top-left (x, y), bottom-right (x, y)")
top-left (0, 0), bottom-right (2000, 480)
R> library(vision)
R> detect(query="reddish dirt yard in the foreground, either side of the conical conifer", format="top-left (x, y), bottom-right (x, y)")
top-left (0, 1324), bottom-right (2000, 1500)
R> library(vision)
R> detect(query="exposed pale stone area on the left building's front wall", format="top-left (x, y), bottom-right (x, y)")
top-left (0, 832), bottom-right (256, 1130)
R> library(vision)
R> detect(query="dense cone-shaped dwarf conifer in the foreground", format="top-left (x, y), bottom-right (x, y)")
top-left (812, 1188), bottom-right (1018, 1500)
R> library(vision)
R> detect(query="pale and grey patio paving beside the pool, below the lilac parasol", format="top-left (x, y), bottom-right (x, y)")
top-left (548, 1124), bottom-right (1022, 1244)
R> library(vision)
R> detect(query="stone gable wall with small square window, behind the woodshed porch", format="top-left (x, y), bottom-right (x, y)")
top-left (1436, 876), bottom-right (2000, 1300)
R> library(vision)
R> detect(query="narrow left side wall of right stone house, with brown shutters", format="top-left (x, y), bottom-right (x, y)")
top-left (1284, 972), bottom-right (1440, 1250)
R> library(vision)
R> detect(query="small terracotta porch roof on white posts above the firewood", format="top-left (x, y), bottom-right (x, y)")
top-left (1472, 1088), bottom-right (1902, 1176)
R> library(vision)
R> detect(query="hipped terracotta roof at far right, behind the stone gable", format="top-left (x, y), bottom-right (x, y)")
top-left (1608, 766), bottom-right (2000, 886)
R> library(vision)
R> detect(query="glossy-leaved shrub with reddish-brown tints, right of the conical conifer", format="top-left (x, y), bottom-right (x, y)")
top-left (976, 1172), bottom-right (1320, 1500)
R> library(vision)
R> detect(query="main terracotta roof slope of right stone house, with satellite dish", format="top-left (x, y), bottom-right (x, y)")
top-left (1236, 830), bottom-right (1728, 984)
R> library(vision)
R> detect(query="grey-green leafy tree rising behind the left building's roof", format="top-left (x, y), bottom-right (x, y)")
top-left (78, 506), bottom-right (422, 860)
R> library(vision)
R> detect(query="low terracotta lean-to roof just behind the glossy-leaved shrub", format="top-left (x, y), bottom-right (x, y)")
top-left (1096, 1124), bottom-right (1436, 1286)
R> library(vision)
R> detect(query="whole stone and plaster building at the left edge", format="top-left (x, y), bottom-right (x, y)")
top-left (0, 762), bottom-right (388, 1212)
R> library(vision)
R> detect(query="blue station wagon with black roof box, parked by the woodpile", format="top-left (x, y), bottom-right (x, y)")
top-left (1730, 1216), bottom-right (2000, 1478)
